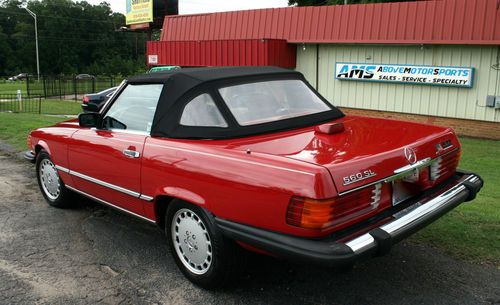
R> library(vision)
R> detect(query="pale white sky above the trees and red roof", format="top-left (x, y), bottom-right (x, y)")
top-left (83, 0), bottom-right (288, 14)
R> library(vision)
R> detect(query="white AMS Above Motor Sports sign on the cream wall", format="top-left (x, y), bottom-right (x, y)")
top-left (335, 62), bottom-right (474, 88)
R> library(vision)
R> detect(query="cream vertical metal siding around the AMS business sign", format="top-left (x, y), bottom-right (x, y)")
top-left (297, 45), bottom-right (500, 122)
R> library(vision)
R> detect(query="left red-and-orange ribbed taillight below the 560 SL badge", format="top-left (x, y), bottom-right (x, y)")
top-left (286, 183), bottom-right (383, 229)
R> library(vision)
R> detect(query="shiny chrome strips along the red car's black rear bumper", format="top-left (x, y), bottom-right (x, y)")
top-left (346, 175), bottom-right (479, 254)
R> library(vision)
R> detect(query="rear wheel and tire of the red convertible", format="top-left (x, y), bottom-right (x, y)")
top-left (165, 199), bottom-right (246, 290)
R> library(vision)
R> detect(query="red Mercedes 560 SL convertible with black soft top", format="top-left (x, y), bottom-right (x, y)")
top-left (26, 67), bottom-right (483, 288)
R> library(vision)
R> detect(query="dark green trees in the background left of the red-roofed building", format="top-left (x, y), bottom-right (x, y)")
top-left (0, 0), bottom-right (147, 75)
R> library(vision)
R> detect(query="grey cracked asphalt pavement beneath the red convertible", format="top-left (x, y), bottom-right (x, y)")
top-left (0, 152), bottom-right (500, 305)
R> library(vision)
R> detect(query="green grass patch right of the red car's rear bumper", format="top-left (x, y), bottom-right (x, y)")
top-left (414, 138), bottom-right (500, 266)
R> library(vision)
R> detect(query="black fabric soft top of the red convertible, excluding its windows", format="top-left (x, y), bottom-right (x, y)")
top-left (115, 67), bottom-right (343, 139)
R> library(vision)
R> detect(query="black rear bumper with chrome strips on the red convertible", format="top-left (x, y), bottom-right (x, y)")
top-left (216, 172), bottom-right (483, 266)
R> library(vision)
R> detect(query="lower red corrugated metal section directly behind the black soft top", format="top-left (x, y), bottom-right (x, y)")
top-left (147, 39), bottom-right (296, 68)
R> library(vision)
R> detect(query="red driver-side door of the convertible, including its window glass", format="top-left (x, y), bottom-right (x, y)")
top-left (68, 84), bottom-right (163, 215)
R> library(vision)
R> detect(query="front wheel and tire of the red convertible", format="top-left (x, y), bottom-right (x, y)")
top-left (36, 150), bottom-right (73, 208)
